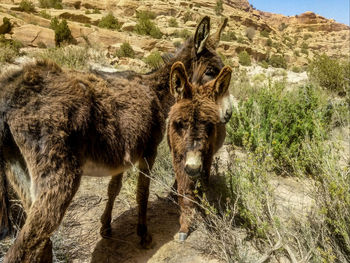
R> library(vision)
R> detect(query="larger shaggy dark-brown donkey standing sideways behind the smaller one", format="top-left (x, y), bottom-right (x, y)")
top-left (0, 17), bottom-right (231, 262)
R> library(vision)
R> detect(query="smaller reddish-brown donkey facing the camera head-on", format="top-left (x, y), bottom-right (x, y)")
top-left (167, 62), bottom-right (232, 241)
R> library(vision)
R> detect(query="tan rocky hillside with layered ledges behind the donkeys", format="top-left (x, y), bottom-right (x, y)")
top-left (0, 0), bottom-right (350, 70)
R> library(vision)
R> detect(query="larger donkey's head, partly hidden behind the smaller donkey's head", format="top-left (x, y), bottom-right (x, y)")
top-left (178, 16), bottom-right (232, 123)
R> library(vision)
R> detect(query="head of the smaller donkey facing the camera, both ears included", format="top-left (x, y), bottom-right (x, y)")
top-left (168, 62), bottom-right (232, 178)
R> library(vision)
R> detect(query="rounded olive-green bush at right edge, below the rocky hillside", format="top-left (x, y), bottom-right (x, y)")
top-left (307, 54), bottom-right (349, 92)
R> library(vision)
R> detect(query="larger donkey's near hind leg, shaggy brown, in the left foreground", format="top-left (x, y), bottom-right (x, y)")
top-left (4, 158), bottom-right (81, 263)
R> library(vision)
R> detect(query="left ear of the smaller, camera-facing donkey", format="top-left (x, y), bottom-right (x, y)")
top-left (170, 61), bottom-right (192, 101)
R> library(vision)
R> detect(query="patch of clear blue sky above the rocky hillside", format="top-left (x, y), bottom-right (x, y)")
top-left (248, 0), bottom-right (349, 25)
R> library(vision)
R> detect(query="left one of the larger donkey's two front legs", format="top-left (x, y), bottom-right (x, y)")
top-left (100, 173), bottom-right (123, 237)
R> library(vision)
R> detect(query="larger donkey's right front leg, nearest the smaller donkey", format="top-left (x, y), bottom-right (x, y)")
top-left (136, 153), bottom-right (156, 248)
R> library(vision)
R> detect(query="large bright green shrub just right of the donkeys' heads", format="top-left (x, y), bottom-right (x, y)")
top-left (227, 83), bottom-right (329, 174)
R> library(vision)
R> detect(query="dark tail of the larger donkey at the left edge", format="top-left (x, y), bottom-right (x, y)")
top-left (0, 112), bottom-right (12, 240)
